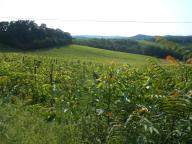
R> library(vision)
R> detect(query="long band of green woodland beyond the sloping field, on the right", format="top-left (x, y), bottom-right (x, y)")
top-left (73, 38), bottom-right (188, 60)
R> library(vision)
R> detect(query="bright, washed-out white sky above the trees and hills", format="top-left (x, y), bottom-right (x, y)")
top-left (0, 0), bottom-right (192, 36)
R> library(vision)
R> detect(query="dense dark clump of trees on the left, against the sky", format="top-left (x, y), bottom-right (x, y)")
top-left (0, 20), bottom-right (72, 50)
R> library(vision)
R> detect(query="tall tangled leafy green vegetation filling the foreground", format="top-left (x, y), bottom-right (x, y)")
top-left (0, 54), bottom-right (192, 144)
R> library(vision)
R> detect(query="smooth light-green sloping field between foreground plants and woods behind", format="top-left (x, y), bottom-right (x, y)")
top-left (1, 45), bottom-right (158, 64)
